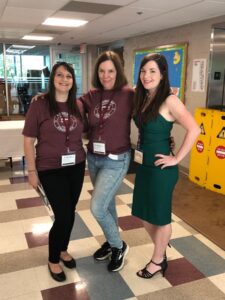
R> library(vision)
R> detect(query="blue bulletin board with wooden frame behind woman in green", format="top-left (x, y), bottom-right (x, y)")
top-left (133, 43), bottom-right (188, 102)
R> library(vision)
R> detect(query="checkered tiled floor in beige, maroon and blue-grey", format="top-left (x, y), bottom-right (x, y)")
top-left (0, 161), bottom-right (225, 300)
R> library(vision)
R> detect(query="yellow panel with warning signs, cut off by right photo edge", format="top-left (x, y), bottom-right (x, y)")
top-left (206, 110), bottom-right (225, 194)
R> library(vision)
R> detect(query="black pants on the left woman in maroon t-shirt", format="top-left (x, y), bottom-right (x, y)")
top-left (38, 161), bottom-right (85, 263)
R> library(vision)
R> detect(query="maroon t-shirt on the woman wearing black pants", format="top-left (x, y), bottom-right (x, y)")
top-left (23, 97), bottom-right (86, 171)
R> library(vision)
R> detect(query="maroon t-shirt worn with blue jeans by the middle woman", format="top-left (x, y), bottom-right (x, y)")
top-left (79, 87), bottom-right (134, 154)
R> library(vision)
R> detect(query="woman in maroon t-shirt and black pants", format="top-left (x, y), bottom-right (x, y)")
top-left (23, 62), bottom-right (86, 281)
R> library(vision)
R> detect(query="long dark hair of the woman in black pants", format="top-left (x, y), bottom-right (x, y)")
top-left (45, 61), bottom-right (82, 119)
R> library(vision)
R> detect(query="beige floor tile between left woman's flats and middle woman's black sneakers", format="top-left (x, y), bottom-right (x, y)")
top-left (68, 237), bottom-right (99, 258)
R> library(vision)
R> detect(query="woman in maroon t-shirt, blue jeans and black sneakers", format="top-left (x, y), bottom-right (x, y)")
top-left (80, 51), bottom-right (134, 271)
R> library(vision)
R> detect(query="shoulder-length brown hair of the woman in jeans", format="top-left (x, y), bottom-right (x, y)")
top-left (92, 51), bottom-right (128, 90)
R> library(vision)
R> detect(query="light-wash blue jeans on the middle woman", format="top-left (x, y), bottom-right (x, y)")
top-left (87, 151), bottom-right (131, 248)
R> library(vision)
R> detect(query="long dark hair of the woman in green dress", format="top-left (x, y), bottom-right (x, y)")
top-left (134, 53), bottom-right (171, 123)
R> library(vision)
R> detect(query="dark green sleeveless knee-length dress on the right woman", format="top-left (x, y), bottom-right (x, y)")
top-left (132, 114), bottom-right (178, 225)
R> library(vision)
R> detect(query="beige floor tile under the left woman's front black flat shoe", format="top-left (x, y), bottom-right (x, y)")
top-left (34, 264), bottom-right (80, 290)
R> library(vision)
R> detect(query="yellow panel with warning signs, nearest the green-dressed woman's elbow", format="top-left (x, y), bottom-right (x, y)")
top-left (189, 108), bottom-right (215, 186)
